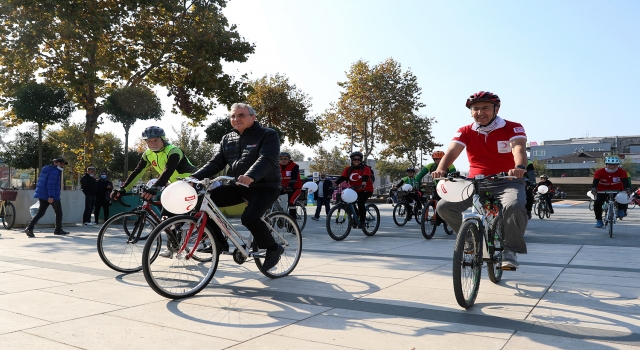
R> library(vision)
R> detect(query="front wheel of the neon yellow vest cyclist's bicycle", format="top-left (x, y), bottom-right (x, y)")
top-left (96, 212), bottom-right (162, 273)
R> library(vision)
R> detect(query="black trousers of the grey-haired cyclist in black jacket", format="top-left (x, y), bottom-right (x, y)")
top-left (211, 185), bottom-right (280, 249)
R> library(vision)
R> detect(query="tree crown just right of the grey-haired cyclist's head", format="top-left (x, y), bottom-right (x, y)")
top-left (247, 74), bottom-right (321, 146)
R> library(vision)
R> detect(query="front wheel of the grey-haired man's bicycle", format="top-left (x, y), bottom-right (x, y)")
top-left (142, 215), bottom-right (219, 299)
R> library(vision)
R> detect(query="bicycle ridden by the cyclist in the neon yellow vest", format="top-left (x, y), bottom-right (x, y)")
top-left (97, 188), bottom-right (162, 273)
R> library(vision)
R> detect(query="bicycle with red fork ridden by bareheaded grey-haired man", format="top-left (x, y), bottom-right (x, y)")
top-left (142, 176), bottom-right (302, 299)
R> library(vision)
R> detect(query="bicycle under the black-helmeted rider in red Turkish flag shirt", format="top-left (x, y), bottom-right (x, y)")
top-left (327, 188), bottom-right (380, 241)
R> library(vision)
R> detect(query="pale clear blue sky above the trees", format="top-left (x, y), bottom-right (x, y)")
top-left (77, 0), bottom-right (640, 169)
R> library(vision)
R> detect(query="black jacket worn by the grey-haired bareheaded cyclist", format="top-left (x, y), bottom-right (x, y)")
top-left (191, 122), bottom-right (282, 188)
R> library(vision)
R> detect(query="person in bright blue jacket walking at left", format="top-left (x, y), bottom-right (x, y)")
top-left (24, 158), bottom-right (69, 238)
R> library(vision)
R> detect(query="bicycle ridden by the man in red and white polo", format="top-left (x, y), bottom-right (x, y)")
top-left (438, 174), bottom-right (515, 309)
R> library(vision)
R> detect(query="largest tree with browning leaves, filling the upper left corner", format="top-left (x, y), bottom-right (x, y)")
top-left (0, 0), bottom-right (254, 161)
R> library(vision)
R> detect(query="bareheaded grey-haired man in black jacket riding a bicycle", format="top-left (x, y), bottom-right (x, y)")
top-left (191, 103), bottom-right (284, 271)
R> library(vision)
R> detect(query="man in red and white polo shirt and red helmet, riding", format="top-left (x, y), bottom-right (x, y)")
top-left (432, 91), bottom-right (528, 269)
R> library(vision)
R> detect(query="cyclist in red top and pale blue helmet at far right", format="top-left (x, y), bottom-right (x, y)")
top-left (591, 156), bottom-right (633, 228)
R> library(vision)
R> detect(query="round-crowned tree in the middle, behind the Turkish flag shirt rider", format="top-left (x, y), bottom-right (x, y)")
top-left (320, 58), bottom-right (424, 159)
